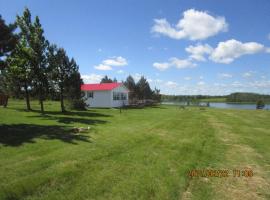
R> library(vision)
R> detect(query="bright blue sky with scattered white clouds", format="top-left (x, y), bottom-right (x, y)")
top-left (0, 0), bottom-right (270, 95)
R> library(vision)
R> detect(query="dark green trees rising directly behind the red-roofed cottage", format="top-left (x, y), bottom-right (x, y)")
top-left (100, 75), bottom-right (161, 102)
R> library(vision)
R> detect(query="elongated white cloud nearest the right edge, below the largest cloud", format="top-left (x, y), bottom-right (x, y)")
top-left (210, 39), bottom-right (266, 64)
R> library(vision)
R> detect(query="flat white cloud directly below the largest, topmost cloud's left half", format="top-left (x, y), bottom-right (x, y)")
top-left (153, 57), bottom-right (197, 71)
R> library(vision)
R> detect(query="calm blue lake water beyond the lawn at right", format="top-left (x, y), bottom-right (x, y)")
top-left (163, 102), bottom-right (270, 110)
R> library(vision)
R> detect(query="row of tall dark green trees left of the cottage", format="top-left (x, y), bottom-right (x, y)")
top-left (0, 8), bottom-right (84, 112)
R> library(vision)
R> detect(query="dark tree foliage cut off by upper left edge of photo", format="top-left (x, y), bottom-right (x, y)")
top-left (0, 15), bottom-right (17, 70)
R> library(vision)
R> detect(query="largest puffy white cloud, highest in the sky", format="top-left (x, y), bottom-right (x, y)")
top-left (152, 9), bottom-right (228, 40)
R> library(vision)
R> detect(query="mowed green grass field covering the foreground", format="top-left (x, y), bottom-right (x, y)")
top-left (0, 101), bottom-right (270, 200)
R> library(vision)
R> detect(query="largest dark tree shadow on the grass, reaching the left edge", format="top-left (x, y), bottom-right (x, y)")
top-left (0, 124), bottom-right (91, 146)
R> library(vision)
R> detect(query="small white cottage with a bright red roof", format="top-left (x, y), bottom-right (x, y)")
top-left (81, 83), bottom-right (129, 108)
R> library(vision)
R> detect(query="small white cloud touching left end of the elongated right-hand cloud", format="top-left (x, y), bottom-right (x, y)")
top-left (185, 44), bottom-right (213, 61)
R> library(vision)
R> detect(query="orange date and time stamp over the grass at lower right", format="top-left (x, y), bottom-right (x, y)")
top-left (188, 169), bottom-right (254, 178)
